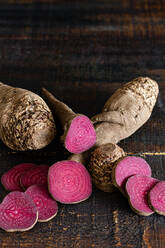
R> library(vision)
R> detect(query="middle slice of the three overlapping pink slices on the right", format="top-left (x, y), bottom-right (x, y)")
top-left (126, 175), bottom-right (158, 216)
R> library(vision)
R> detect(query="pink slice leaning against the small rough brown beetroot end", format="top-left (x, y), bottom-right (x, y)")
top-left (112, 156), bottom-right (151, 194)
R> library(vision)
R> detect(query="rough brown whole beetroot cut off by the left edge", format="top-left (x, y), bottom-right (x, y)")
top-left (0, 83), bottom-right (56, 151)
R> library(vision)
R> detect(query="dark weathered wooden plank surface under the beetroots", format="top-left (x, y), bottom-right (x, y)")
top-left (0, 0), bottom-right (165, 248)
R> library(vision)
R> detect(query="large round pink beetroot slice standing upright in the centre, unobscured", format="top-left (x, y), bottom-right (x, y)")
top-left (48, 160), bottom-right (92, 204)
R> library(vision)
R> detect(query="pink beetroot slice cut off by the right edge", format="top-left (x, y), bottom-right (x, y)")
top-left (149, 181), bottom-right (165, 215)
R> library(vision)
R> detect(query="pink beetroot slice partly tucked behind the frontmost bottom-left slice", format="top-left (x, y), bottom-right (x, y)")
top-left (25, 184), bottom-right (58, 222)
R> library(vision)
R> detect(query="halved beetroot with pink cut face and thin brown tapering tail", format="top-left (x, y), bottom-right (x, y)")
top-left (42, 88), bottom-right (96, 154)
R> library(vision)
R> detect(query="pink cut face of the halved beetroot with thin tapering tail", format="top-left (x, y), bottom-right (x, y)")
top-left (65, 115), bottom-right (96, 154)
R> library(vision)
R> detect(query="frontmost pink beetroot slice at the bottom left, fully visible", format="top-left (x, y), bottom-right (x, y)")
top-left (0, 191), bottom-right (38, 232)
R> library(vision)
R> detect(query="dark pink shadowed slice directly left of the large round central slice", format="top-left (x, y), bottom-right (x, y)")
top-left (20, 165), bottom-right (49, 189)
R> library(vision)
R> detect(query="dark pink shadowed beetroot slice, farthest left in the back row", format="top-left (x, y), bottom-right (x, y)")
top-left (1, 163), bottom-right (36, 191)
